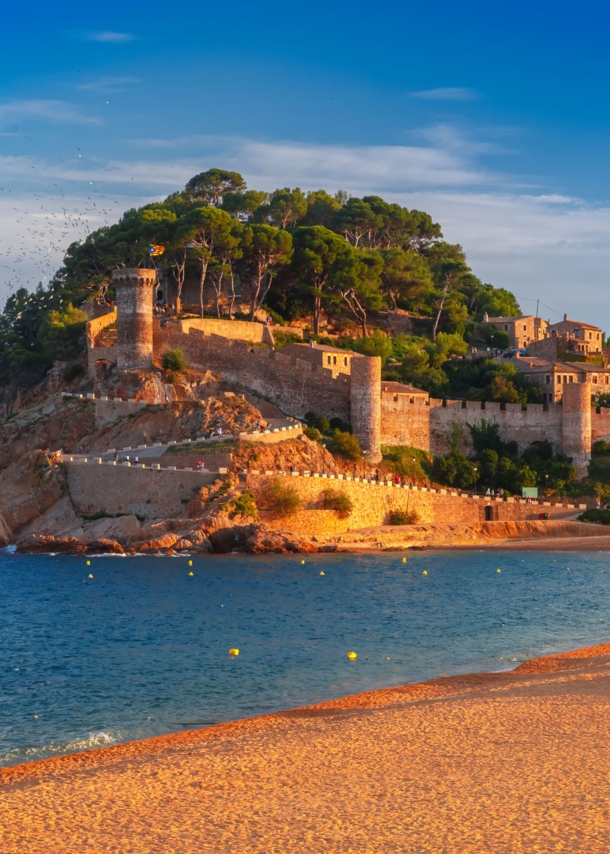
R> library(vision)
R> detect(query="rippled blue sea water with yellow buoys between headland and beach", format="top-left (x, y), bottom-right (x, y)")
top-left (0, 551), bottom-right (610, 765)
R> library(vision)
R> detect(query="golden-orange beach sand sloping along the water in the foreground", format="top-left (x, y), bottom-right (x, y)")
top-left (0, 644), bottom-right (610, 854)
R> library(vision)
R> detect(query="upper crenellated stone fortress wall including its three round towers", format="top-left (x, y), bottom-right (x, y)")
top-left (83, 269), bottom-right (592, 474)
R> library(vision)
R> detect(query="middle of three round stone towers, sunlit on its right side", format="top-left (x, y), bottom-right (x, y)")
top-left (350, 356), bottom-right (381, 463)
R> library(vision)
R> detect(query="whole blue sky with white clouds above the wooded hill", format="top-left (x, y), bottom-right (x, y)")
top-left (0, 0), bottom-right (610, 331)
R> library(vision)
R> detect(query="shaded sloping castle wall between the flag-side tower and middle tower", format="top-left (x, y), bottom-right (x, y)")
top-left (154, 323), bottom-right (350, 420)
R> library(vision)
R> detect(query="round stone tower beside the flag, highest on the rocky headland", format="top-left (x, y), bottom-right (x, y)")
top-left (112, 267), bottom-right (157, 371)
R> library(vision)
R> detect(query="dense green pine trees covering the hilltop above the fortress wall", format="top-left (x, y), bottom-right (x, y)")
top-left (0, 168), bottom-right (524, 392)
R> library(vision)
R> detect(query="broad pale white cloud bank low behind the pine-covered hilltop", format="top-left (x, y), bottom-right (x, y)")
top-left (0, 135), bottom-right (610, 331)
